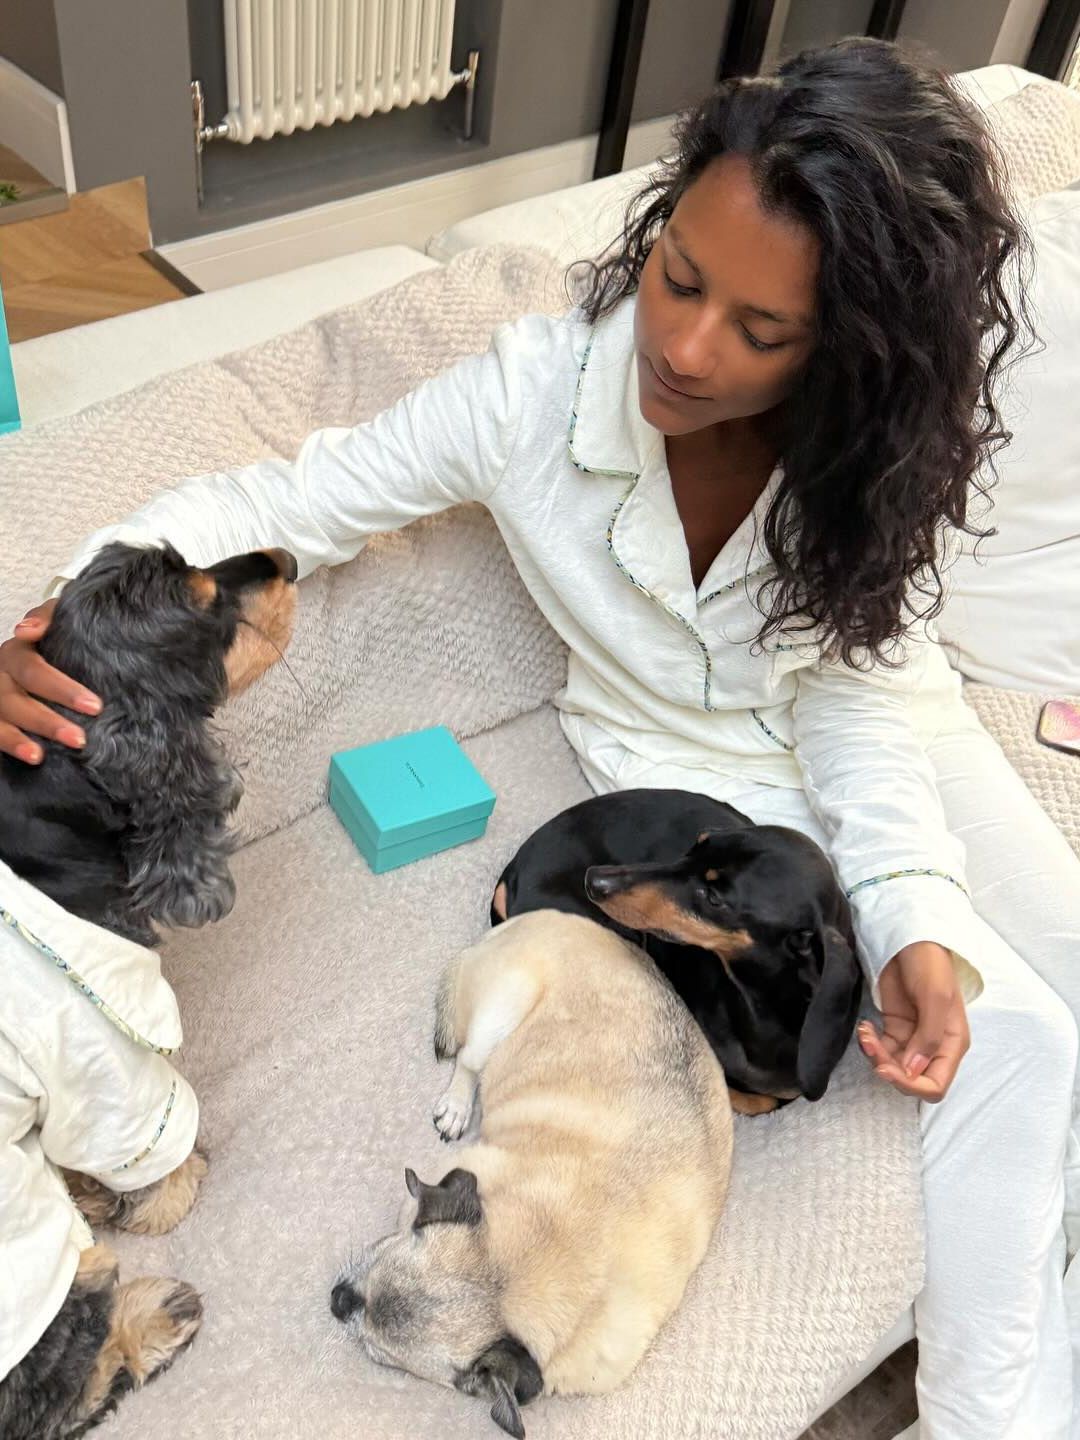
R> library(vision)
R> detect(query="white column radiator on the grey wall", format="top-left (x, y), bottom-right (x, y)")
top-left (193, 0), bottom-right (478, 147)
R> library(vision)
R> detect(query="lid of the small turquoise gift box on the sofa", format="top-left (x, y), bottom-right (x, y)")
top-left (330, 726), bottom-right (495, 847)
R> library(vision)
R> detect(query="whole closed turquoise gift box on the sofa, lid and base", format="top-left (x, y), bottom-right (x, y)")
top-left (330, 726), bottom-right (495, 876)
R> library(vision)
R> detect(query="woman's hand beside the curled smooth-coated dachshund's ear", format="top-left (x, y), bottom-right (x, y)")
top-left (858, 940), bottom-right (971, 1104)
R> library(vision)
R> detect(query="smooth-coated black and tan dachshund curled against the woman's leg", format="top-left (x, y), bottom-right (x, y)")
top-left (491, 789), bottom-right (863, 1115)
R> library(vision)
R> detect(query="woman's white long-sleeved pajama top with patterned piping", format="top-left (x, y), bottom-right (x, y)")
top-left (60, 298), bottom-right (978, 992)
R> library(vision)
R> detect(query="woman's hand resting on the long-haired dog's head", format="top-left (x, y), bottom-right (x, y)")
top-left (0, 600), bottom-right (101, 765)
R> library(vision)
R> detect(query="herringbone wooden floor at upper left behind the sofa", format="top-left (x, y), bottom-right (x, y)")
top-left (0, 171), bottom-right (192, 343)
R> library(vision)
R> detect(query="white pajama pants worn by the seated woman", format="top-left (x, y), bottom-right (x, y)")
top-left (566, 704), bottom-right (1080, 1440)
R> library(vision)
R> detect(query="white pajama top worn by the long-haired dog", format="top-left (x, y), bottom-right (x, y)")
top-left (0, 863), bottom-right (199, 1380)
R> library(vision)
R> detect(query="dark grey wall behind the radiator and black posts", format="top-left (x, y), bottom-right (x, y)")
top-left (25, 0), bottom-right (1054, 243)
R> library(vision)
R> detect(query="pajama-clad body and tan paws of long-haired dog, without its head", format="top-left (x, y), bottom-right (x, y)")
top-left (0, 864), bottom-right (206, 1440)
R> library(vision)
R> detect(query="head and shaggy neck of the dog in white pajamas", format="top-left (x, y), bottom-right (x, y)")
top-left (0, 544), bottom-right (297, 945)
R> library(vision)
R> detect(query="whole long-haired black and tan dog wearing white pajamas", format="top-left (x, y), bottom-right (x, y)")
top-left (0, 544), bottom-right (297, 1440)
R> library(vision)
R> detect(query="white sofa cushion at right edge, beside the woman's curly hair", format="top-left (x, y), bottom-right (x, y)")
top-left (939, 187), bottom-right (1080, 696)
